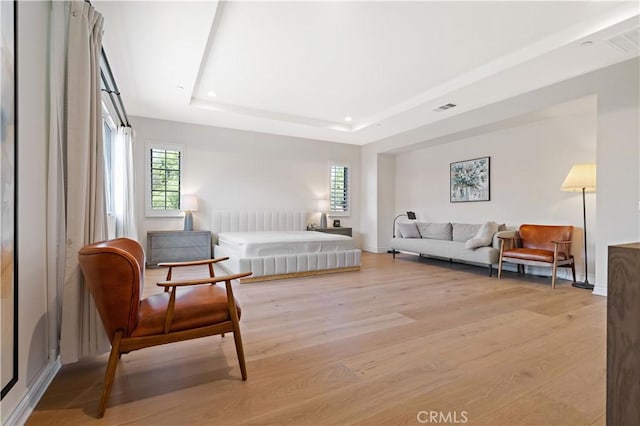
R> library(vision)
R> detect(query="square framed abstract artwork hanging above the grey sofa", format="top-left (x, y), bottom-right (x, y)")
top-left (449, 157), bottom-right (491, 203)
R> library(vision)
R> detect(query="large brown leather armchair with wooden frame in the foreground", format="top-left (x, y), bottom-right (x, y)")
top-left (78, 238), bottom-right (251, 417)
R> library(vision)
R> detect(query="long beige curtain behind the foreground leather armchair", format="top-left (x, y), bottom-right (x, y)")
top-left (47, 0), bottom-right (109, 364)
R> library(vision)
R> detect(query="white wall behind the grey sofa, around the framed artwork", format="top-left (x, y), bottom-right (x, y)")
top-left (389, 105), bottom-right (596, 281)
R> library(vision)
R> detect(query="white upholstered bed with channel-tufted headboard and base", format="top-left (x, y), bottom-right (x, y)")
top-left (211, 211), bottom-right (361, 282)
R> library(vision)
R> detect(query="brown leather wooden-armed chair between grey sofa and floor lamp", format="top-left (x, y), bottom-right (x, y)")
top-left (498, 225), bottom-right (576, 288)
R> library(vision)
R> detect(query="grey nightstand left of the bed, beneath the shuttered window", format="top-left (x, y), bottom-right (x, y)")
top-left (147, 231), bottom-right (211, 268)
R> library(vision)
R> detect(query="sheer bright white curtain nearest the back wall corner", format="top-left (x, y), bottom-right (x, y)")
top-left (113, 126), bottom-right (138, 240)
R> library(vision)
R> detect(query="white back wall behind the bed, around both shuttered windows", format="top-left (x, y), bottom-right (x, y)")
top-left (131, 117), bottom-right (360, 248)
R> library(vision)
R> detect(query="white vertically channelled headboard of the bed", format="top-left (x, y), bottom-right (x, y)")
top-left (211, 210), bottom-right (308, 234)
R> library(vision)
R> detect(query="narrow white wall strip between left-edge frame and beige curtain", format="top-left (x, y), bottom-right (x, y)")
top-left (0, 2), bottom-right (52, 424)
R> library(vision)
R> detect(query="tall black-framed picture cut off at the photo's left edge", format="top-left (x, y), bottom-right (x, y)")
top-left (0, 1), bottom-right (18, 399)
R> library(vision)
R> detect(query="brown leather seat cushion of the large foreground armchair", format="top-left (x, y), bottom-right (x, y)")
top-left (131, 285), bottom-right (240, 337)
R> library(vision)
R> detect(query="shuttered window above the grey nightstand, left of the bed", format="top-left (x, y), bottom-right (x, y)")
top-left (145, 143), bottom-right (183, 216)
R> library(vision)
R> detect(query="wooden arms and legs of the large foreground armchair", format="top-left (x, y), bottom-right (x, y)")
top-left (90, 258), bottom-right (251, 417)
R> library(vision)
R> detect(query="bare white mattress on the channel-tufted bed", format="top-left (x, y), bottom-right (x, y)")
top-left (218, 231), bottom-right (355, 258)
